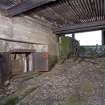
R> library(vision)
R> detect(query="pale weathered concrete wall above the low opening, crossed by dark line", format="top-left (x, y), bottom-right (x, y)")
top-left (0, 15), bottom-right (56, 54)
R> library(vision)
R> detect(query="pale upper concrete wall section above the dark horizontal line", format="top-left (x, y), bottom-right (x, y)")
top-left (0, 15), bottom-right (51, 44)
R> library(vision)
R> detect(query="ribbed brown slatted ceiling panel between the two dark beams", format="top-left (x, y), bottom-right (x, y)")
top-left (34, 0), bottom-right (105, 33)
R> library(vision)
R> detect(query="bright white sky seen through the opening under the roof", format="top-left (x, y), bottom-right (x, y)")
top-left (66, 31), bottom-right (102, 45)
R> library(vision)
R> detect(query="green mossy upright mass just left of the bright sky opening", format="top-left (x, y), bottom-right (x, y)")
top-left (59, 36), bottom-right (79, 63)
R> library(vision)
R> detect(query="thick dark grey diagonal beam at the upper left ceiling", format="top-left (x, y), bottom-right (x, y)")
top-left (7, 0), bottom-right (56, 16)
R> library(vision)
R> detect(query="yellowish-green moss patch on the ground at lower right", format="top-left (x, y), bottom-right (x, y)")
top-left (63, 80), bottom-right (93, 105)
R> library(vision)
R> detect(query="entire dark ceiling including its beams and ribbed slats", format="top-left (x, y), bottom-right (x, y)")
top-left (0, 0), bottom-right (105, 34)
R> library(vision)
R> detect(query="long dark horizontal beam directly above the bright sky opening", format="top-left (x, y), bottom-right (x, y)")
top-left (54, 21), bottom-right (105, 35)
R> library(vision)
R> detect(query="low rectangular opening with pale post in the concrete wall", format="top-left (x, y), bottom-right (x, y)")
top-left (10, 49), bottom-right (35, 74)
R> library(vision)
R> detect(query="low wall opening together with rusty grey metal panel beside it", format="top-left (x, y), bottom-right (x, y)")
top-left (9, 49), bottom-right (48, 75)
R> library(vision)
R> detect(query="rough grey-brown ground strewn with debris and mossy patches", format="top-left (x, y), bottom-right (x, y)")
top-left (0, 58), bottom-right (105, 105)
